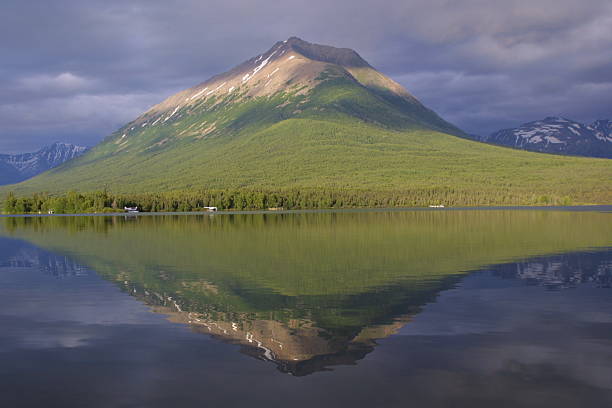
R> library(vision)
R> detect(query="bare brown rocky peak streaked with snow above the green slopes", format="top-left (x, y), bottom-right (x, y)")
top-left (139, 37), bottom-right (444, 126)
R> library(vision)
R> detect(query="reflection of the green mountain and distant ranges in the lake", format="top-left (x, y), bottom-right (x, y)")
top-left (4, 211), bottom-right (611, 376)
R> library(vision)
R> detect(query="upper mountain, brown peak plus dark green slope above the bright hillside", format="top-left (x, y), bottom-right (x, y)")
top-left (129, 37), bottom-right (461, 137)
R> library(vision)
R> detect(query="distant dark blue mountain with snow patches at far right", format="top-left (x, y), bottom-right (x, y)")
top-left (480, 117), bottom-right (612, 158)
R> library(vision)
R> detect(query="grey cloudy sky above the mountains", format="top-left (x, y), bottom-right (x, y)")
top-left (0, 0), bottom-right (612, 153)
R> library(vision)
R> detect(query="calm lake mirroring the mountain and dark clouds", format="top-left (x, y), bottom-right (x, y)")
top-left (0, 207), bottom-right (612, 407)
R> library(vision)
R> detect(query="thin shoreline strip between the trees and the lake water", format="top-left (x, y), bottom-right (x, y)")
top-left (0, 204), bottom-right (612, 218)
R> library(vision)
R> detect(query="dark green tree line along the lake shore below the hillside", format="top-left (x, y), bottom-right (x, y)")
top-left (2, 187), bottom-right (584, 214)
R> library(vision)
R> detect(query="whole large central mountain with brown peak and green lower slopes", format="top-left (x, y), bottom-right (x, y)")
top-left (0, 37), bottom-right (612, 205)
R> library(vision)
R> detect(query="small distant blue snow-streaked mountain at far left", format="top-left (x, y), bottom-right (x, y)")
top-left (0, 143), bottom-right (87, 185)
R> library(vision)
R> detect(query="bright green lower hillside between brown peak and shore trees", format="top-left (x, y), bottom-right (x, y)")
top-left (7, 119), bottom-right (612, 204)
